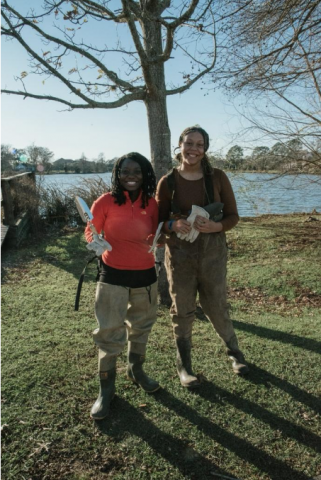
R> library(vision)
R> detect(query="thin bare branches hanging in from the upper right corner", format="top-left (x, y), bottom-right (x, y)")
top-left (215, 0), bottom-right (321, 172)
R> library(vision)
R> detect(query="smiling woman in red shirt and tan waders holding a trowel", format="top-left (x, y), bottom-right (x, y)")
top-left (85, 152), bottom-right (160, 420)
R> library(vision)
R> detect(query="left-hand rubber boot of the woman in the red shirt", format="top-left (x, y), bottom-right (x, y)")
top-left (90, 366), bottom-right (116, 420)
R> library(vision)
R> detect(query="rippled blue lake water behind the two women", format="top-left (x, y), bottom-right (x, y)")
top-left (37, 172), bottom-right (321, 217)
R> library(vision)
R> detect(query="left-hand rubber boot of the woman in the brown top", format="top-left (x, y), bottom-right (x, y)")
top-left (176, 338), bottom-right (200, 388)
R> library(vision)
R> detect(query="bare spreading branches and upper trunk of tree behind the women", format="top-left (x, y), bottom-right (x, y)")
top-left (1, 0), bottom-right (221, 176)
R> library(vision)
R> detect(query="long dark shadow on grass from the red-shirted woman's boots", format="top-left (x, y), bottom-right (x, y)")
top-left (96, 396), bottom-right (235, 479)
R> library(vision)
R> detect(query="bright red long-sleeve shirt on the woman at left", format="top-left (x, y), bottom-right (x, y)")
top-left (85, 192), bottom-right (158, 270)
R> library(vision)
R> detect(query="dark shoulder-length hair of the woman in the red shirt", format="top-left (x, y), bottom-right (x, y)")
top-left (111, 152), bottom-right (156, 208)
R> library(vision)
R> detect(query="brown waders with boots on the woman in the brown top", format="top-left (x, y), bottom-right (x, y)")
top-left (165, 232), bottom-right (248, 388)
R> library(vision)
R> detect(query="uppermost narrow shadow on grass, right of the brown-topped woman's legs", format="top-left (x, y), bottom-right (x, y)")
top-left (233, 320), bottom-right (321, 354)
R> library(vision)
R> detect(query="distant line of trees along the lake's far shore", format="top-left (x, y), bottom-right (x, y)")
top-left (1, 139), bottom-right (321, 175)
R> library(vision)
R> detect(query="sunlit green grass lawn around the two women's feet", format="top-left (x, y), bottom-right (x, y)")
top-left (2, 215), bottom-right (321, 480)
